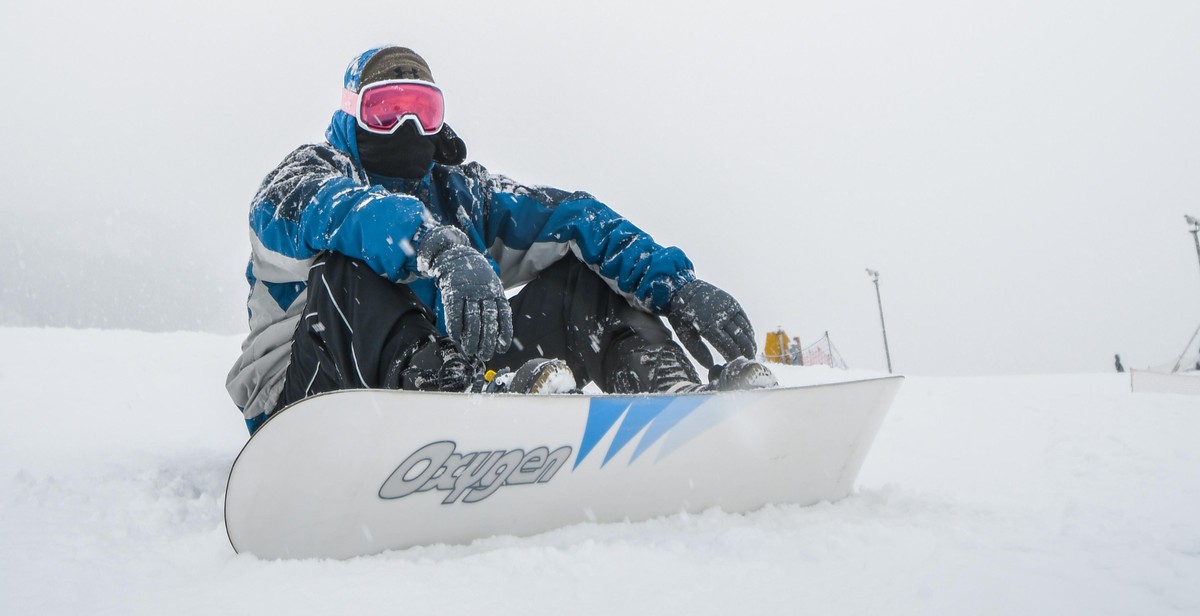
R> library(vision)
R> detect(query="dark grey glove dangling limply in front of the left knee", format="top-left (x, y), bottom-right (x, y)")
top-left (416, 226), bottom-right (512, 361)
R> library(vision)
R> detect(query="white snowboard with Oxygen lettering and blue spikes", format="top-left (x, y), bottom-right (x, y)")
top-left (226, 377), bottom-right (902, 558)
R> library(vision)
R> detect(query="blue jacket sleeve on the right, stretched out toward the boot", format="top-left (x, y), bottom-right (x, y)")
top-left (476, 164), bottom-right (696, 313)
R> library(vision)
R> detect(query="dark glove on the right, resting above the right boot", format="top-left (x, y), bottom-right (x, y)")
top-left (667, 280), bottom-right (757, 367)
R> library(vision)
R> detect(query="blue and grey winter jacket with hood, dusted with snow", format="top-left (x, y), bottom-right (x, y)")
top-left (227, 52), bottom-right (695, 419)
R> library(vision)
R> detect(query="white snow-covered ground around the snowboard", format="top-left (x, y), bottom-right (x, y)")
top-left (0, 328), bottom-right (1200, 616)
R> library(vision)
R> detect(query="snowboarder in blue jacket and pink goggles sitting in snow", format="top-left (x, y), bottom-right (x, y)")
top-left (227, 47), bottom-right (775, 433)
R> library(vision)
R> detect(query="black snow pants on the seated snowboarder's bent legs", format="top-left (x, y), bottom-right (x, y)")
top-left (276, 252), bottom-right (671, 408)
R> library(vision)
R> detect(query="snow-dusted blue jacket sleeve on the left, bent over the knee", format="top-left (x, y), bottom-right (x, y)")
top-left (250, 145), bottom-right (425, 282)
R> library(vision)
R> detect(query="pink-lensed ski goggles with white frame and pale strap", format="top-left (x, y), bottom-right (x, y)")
top-left (342, 79), bottom-right (445, 136)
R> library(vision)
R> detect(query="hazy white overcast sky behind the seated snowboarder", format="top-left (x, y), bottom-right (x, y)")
top-left (0, 0), bottom-right (1200, 375)
